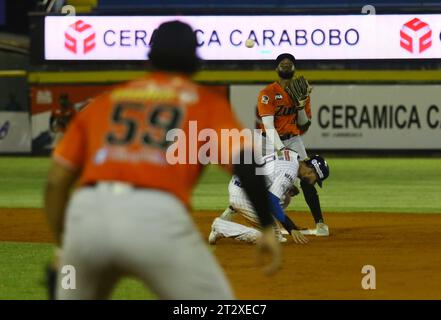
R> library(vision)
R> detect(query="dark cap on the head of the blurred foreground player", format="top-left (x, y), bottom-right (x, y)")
top-left (148, 20), bottom-right (200, 73)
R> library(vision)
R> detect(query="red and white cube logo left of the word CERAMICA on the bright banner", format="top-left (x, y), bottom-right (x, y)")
top-left (64, 20), bottom-right (95, 54)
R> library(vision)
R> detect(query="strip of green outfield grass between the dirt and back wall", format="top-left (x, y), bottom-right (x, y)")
top-left (0, 157), bottom-right (441, 213)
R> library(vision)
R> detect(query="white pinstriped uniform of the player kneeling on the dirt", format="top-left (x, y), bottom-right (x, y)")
top-left (212, 150), bottom-right (299, 243)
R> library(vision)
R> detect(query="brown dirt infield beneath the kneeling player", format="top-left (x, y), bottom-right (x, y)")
top-left (0, 209), bottom-right (441, 299)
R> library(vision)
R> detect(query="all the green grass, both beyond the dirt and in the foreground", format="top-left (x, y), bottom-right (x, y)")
top-left (0, 157), bottom-right (441, 299)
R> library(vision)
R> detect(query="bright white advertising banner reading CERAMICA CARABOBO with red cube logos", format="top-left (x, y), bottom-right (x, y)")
top-left (44, 14), bottom-right (441, 60)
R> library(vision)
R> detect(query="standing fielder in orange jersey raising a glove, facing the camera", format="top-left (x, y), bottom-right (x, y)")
top-left (257, 53), bottom-right (329, 236)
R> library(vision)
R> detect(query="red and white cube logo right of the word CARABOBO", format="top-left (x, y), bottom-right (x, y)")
top-left (400, 18), bottom-right (432, 53)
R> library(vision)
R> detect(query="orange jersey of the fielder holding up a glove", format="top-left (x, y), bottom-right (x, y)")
top-left (257, 81), bottom-right (311, 136)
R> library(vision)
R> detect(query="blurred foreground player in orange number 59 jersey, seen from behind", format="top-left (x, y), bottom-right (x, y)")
top-left (45, 21), bottom-right (281, 299)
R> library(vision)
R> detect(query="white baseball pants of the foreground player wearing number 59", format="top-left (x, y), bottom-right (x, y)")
top-left (56, 183), bottom-right (234, 300)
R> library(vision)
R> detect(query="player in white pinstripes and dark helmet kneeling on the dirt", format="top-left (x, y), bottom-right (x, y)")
top-left (208, 149), bottom-right (329, 244)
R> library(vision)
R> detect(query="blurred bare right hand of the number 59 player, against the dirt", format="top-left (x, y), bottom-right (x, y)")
top-left (257, 227), bottom-right (282, 275)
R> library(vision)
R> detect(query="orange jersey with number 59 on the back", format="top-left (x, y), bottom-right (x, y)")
top-left (54, 73), bottom-right (244, 205)
